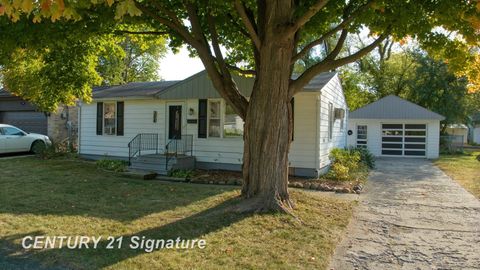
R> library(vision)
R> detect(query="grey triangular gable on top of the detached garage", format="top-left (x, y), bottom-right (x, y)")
top-left (349, 95), bottom-right (445, 120)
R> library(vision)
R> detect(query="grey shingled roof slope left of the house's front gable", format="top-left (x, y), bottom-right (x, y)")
top-left (92, 81), bottom-right (179, 98)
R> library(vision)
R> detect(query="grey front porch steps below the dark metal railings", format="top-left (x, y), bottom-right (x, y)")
top-left (129, 154), bottom-right (195, 175)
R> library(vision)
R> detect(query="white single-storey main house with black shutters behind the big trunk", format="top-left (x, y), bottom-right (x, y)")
top-left (79, 71), bottom-right (347, 177)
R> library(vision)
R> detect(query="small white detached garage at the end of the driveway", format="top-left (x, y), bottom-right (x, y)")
top-left (347, 95), bottom-right (445, 158)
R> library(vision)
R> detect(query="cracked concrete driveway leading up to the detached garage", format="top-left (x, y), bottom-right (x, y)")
top-left (330, 158), bottom-right (480, 270)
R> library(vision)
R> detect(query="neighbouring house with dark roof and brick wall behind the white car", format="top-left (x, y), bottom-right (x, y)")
top-left (0, 89), bottom-right (78, 142)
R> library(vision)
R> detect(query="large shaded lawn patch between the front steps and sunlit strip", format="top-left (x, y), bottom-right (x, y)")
top-left (0, 159), bottom-right (236, 222)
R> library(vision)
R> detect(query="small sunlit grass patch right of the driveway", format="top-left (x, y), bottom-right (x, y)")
top-left (435, 151), bottom-right (480, 198)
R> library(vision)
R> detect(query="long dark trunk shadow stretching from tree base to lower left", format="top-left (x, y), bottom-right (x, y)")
top-left (0, 197), bottom-right (252, 269)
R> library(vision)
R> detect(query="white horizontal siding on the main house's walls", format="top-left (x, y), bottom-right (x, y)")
top-left (80, 92), bottom-right (326, 169)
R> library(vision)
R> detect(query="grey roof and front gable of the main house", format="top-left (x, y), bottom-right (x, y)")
top-left (93, 70), bottom-right (337, 99)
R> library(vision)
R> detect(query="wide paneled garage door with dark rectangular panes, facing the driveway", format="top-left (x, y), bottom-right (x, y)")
top-left (382, 124), bottom-right (427, 157)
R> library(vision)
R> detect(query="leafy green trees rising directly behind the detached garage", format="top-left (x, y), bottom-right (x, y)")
top-left (342, 46), bottom-right (472, 130)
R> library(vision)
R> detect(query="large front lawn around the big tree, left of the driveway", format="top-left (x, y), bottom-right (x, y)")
top-left (0, 158), bottom-right (353, 269)
